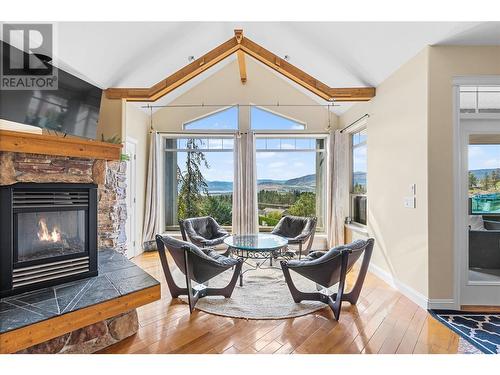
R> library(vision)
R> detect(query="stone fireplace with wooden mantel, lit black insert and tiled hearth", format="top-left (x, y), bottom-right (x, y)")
top-left (0, 134), bottom-right (160, 353)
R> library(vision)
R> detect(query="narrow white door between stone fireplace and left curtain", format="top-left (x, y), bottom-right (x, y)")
top-left (126, 138), bottom-right (137, 258)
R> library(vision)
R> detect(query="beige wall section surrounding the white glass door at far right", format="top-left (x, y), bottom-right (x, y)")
top-left (428, 46), bottom-right (500, 299)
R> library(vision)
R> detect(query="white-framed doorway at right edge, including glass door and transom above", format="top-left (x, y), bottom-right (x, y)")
top-left (455, 81), bottom-right (500, 307)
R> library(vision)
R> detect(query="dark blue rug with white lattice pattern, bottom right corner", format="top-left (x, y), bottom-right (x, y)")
top-left (430, 310), bottom-right (500, 354)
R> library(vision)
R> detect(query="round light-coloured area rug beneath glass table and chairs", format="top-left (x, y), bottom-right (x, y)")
top-left (173, 263), bottom-right (326, 319)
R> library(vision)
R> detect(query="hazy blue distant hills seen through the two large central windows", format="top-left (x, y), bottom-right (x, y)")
top-left (207, 174), bottom-right (316, 193)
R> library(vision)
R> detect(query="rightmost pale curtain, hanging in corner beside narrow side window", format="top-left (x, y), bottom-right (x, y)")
top-left (328, 130), bottom-right (350, 247)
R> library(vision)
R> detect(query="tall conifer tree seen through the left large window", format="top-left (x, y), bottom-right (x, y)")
top-left (177, 138), bottom-right (209, 219)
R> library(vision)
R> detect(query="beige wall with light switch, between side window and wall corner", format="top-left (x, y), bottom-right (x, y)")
top-left (340, 49), bottom-right (428, 297)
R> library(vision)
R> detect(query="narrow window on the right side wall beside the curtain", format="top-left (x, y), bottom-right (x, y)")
top-left (351, 129), bottom-right (367, 225)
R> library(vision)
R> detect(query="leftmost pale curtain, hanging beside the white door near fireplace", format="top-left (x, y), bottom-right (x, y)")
top-left (142, 132), bottom-right (161, 250)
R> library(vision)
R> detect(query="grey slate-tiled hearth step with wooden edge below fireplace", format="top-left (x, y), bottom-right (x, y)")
top-left (0, 249), bottom-right (160, 353)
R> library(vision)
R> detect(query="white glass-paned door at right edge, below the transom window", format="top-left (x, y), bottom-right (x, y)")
top-left (460, 119), bottom-right (500, 306)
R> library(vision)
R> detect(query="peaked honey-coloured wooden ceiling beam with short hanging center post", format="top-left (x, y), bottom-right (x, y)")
top-left (105, 29), bottom-right (375, 102)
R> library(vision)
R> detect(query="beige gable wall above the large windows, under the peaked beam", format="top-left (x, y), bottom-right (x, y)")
top-left (153, 57), bottom-right (338, 132)
